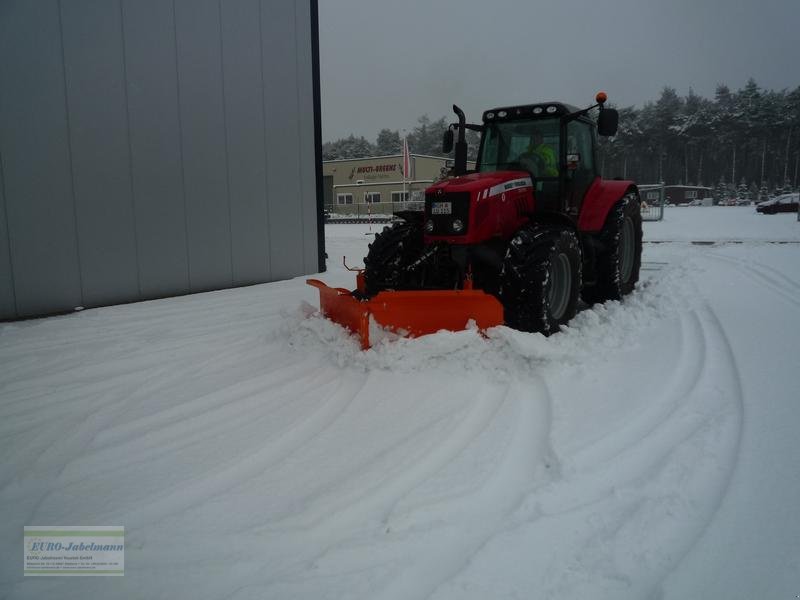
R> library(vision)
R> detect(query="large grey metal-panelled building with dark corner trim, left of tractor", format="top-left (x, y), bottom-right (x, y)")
top-left (0, 0), bottom-right (324, 319)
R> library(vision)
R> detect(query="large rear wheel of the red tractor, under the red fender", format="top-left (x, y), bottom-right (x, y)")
top-left (582, 193), bottom-right (642, 304)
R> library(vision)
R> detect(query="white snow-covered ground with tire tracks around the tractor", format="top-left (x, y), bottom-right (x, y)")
top-left (0, 207), bottom-right (800, 600)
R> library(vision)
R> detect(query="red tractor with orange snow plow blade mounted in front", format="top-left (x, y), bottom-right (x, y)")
top-left (310, 92), bottom-right (642, 348)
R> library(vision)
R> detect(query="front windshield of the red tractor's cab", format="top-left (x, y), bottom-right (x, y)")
top-left (478, 118), bottom-right (559, 178)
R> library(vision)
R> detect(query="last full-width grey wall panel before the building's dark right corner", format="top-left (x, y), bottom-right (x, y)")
top-left (261, 0), bottom-right (310, 279)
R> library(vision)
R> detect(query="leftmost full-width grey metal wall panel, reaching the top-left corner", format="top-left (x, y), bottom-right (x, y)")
top-left (0, 0), bottom-right (82, 316)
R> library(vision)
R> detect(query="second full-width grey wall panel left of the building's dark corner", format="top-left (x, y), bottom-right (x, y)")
top-left (222, 0), bottom-right (271, 285)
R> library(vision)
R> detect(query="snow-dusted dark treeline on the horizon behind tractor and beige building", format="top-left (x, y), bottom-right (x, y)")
top-left (323, 79), bottom-right (800, 188)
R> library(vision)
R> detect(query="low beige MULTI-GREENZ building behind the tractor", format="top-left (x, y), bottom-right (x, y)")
top-left (322, 154), bottom-right (475, 216)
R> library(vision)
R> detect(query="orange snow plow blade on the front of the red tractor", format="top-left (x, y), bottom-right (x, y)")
top-left (306, 279), bottom-right (503, 350)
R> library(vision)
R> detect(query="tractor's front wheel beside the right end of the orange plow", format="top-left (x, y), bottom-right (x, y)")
top-left (500, 227), bottom-right (581, 335)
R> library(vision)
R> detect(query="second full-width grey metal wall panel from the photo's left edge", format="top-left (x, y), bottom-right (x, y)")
top-left (61, 0), bottom-right (139, 306)
